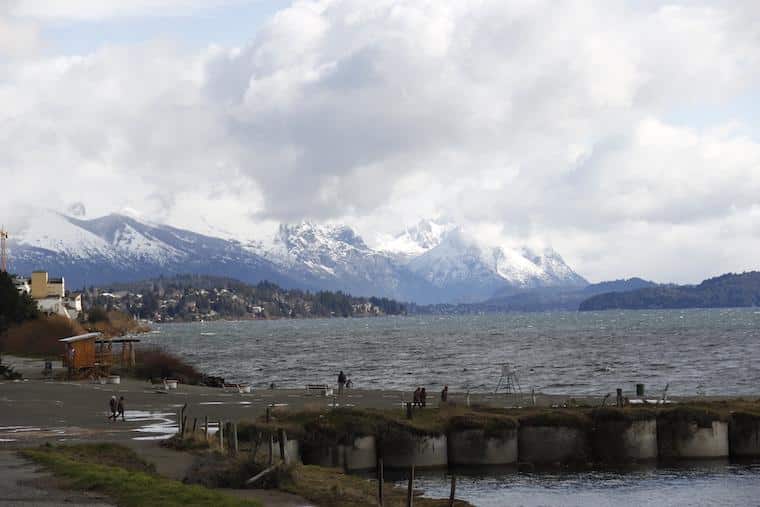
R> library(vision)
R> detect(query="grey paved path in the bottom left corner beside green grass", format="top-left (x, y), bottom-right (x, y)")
top-left (0, 451), bottom-right (113, 507)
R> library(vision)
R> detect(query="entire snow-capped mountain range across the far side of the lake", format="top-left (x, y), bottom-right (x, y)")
top-left (9, 210), bottom-right (588, 304)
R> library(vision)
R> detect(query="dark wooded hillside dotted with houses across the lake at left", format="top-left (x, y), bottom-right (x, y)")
top-left (82, 275), bottom-right (406, 322)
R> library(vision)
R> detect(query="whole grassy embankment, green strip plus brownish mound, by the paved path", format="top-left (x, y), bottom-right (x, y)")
top-left (23, 444), bottom-right (260, 507)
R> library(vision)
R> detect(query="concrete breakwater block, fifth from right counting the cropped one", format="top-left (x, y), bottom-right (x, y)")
top-left (448, 429), bottom-right (518, 465)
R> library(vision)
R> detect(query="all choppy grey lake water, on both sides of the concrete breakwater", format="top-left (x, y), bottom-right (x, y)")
top-left (141, 309), bottom-right (760, 507)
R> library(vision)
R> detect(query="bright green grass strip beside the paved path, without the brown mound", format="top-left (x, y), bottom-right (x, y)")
top-left (23, 448), bottom-right (260, 507)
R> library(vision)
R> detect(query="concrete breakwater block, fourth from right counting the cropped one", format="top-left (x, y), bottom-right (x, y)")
top-left (518, 426), bottom-right (591, 464)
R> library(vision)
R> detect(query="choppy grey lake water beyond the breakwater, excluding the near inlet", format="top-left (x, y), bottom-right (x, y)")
top-left (141, 309), bottom-right (760, 395)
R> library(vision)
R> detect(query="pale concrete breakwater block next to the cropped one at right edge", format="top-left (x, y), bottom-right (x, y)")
top-left (657, 413), bottom-right (729, 459)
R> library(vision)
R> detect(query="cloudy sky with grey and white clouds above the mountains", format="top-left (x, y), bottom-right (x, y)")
top-left (0, 0), bottom-right (760, 282)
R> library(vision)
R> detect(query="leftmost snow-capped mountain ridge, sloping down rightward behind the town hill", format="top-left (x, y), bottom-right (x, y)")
top-left (9, 211), bottom-right (299, 288)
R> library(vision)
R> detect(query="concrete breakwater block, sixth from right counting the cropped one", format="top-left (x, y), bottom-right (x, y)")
top-left (381, 433), bottom-right (449, 468)
